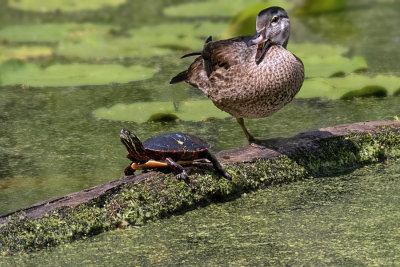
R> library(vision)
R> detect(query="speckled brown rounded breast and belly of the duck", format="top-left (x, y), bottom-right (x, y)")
top-left (208, 46), bottom-right (304, 118)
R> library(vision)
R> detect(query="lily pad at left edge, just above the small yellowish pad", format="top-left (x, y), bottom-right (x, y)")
top-left (0, 23), bottom-right (115, 43)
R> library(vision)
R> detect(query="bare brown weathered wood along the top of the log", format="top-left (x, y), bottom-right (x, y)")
top-left (0, 121), bottom-right (400, 225)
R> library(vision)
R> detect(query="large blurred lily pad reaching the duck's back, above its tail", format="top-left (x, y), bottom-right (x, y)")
top-left (56, 22), bottom-right (227, 58)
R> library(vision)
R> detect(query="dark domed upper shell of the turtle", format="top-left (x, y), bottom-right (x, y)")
top-left (143, 133), bottom-right (210, 152)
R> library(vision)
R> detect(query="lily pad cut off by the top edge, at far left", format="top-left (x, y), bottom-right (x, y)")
top-left (8, 0), bottom-right (126, 12)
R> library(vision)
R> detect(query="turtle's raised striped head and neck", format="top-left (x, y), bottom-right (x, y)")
top-left (119, 129), bottom-right (148, 162)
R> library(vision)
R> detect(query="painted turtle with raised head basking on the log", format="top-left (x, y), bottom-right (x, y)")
top-left (120, 129), bottom-right (232, 179)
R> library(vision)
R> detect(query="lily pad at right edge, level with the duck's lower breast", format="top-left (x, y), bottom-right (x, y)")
top-left (296, 74), bottom-right (400, 99)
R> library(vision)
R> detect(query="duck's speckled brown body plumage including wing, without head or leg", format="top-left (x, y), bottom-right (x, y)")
top-left (186, 36), bottom-right (304, 119)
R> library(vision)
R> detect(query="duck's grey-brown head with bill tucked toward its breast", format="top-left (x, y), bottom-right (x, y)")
top-left (247, 6), bottom-right (290, 64)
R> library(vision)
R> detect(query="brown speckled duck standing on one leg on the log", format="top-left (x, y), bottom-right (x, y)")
top-left (170, 6), bottom-right (304, 144)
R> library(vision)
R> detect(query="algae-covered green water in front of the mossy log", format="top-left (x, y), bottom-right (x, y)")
top-left (2, 160), bottom-right (400, 266)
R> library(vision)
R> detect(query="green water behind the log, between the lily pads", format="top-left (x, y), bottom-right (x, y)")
top-left (0, 1), bottom-right (400, 216)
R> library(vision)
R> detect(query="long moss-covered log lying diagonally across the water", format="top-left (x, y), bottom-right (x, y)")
top-left (0, 121), bottom-right (400, 253)
